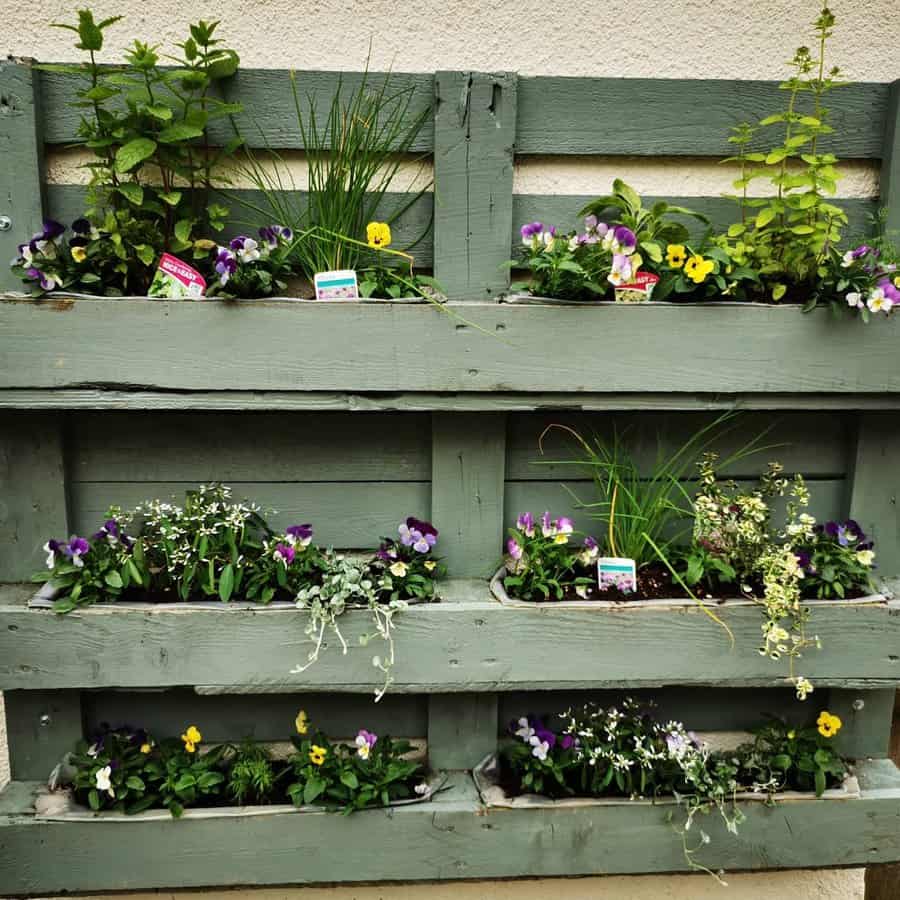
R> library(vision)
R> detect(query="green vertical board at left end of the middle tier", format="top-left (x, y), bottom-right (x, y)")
top-left (0, 413), bottom-right (68, 581)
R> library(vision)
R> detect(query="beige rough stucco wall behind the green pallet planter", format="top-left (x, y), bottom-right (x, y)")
top-left (0, 0), bottom-right (900, 900)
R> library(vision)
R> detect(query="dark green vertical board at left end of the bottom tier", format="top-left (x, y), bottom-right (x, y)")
top-left (3, 691), bottom-right (82, 781)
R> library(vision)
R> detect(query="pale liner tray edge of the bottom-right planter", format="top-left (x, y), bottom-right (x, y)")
top-left (472, 753), bottom-right (861, 809)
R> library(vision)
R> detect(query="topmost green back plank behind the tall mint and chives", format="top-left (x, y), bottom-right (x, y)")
top-left (40, 69), bottom-right (434, 151)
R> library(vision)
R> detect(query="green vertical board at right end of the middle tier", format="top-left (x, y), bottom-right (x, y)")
top-left (850, 413), bottom-right (900, 576)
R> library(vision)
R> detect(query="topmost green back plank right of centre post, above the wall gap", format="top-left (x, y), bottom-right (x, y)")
top-left (516, 76), bottom-right (890, 159)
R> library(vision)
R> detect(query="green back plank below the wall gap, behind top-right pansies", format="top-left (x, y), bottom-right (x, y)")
top-left (511, 193), bottom-right (878, 243)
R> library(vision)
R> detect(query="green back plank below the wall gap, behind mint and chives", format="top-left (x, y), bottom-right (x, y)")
top-left (46, 184), bottom-right (436, 269)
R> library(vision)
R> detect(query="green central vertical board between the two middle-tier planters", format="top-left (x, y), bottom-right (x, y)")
top-left (431, 413), bottom-right (506, 578)
